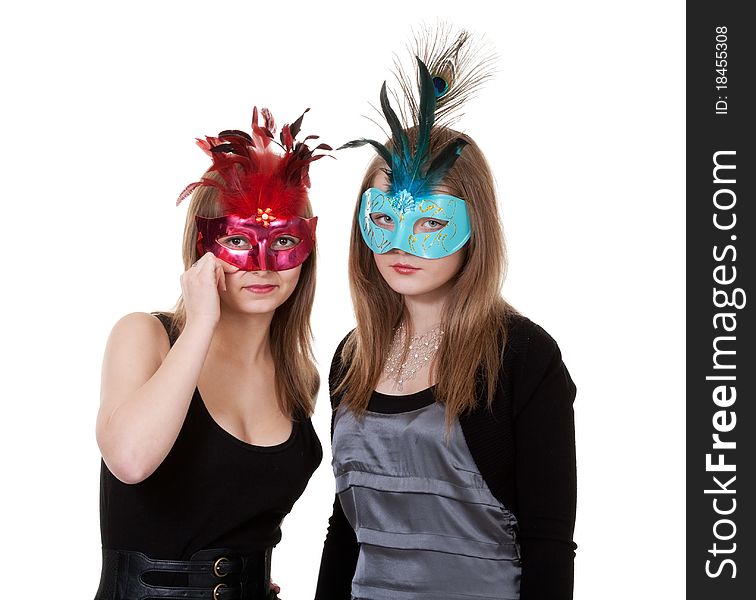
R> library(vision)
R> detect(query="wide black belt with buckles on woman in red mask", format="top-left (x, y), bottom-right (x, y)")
top-left (95, 548), bottom-right (277, 600)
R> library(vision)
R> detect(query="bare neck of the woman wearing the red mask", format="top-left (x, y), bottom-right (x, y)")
top-left (209, 311), bottom-right (273, 367)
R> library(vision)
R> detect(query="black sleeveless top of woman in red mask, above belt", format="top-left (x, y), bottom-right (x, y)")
top-left (100, 314), bottom-right (323, 560)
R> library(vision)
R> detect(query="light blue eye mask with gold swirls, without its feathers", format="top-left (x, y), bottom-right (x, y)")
top-left (360, 188), bottom-right (470, 258)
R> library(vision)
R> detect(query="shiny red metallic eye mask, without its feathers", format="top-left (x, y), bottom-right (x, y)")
top-left (195, 213), bottom-right (318, 271)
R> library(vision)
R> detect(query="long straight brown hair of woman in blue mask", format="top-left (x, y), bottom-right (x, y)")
top-left (335, 128), bottom-right (516, 427)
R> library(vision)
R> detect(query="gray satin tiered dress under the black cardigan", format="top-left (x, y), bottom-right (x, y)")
top-left (333, 394), bottom-right (520, 600)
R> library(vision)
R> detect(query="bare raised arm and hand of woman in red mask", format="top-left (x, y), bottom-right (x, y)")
top-left (97, 254), bottom-right (233, 483)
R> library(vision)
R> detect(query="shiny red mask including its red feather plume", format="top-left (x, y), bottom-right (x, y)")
top-left (176, 107), bottom-right (331, 271)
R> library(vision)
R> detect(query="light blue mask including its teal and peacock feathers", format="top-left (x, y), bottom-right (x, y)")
top-left (340, 41), bottom-right (489, 258)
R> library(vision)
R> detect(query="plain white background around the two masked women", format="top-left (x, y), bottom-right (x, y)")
top-left (0, 0), bottom-right (685, 600)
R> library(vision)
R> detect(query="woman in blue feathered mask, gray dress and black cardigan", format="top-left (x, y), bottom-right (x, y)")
top-left (316, 33), bottom-right (576, 600)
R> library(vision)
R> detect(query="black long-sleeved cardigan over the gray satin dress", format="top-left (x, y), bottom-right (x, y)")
top-left (316, 315), bottom-right (577, 600)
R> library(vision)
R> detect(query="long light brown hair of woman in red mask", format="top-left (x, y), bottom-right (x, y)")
top-left (168, 173), bottom-right (320, 419)
